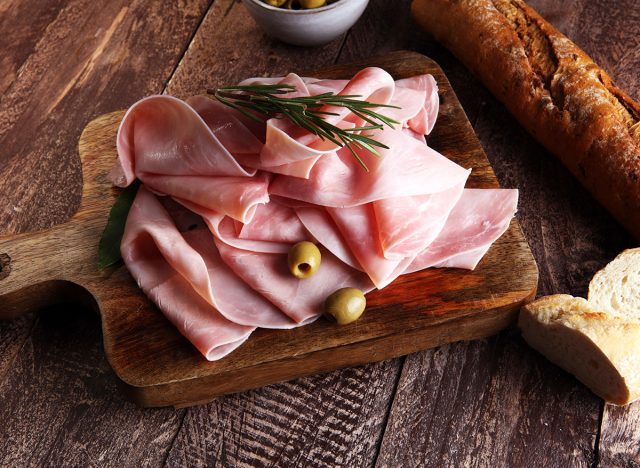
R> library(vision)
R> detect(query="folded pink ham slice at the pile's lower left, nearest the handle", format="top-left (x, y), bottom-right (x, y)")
top-left (121, 187), bottom-right (255, 360)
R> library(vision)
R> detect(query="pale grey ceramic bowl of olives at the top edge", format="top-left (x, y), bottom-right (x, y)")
top-left (242, 0), bottom-right (369, 46)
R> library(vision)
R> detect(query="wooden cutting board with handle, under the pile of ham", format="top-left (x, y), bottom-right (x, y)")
top-left (0, 52), bottom-right (538, 406)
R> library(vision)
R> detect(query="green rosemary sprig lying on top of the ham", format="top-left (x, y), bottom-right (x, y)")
top-left (207, 84), bottom-right (400, 171)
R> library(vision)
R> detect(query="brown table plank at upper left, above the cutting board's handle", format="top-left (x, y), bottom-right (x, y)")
top-left (0, 0), bottom-right (206, 233)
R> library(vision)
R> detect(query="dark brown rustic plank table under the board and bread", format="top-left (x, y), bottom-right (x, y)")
top-left (0, 0), bottom-right (640, 466)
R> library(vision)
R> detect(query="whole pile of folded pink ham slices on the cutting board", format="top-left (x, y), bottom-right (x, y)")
top-left (111, 68), bottom-right (518, 360)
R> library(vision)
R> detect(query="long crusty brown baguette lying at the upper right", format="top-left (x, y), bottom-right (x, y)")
top-left (411, 0), bottom-right (640, 239)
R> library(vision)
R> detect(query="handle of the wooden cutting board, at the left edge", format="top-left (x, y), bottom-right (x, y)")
top-left (0, 222), bottom-right (95, 319)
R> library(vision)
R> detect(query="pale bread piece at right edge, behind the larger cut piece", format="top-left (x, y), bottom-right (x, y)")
top-left (589, 248), bottom-right (640, 320)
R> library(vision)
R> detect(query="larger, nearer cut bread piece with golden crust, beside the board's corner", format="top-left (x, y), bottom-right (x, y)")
top-left (518, 294), bottom-right (640, 405)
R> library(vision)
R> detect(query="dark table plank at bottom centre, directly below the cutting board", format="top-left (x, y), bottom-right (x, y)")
top-left (167, 361), bottom-right (399, 466)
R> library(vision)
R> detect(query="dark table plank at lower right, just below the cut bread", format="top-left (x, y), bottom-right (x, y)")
top-left (377, 334), bottom-right (598, 467)
